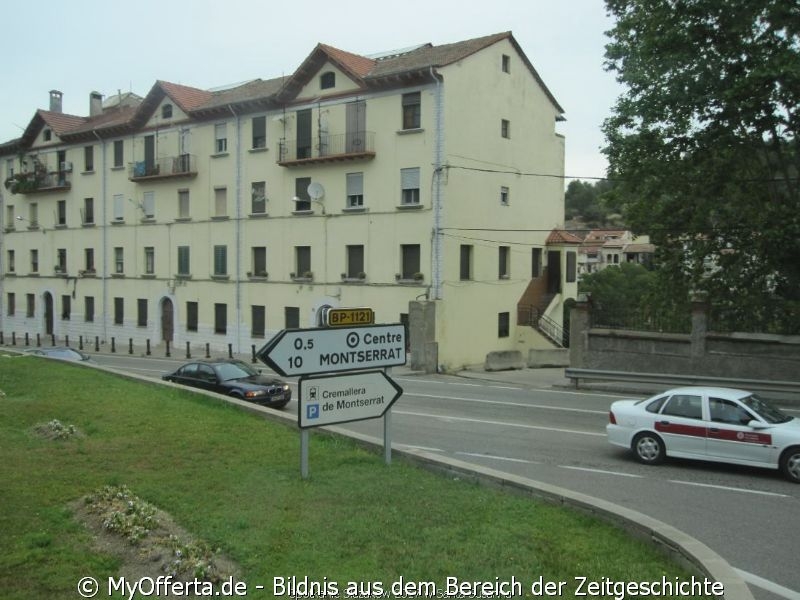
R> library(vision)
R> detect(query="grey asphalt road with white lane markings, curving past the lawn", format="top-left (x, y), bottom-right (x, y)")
top-left (89, 355), bottom-right (800, 600)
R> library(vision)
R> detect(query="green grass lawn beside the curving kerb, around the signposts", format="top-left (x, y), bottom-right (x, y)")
top-left (0, 356), bottom-right (712, 600)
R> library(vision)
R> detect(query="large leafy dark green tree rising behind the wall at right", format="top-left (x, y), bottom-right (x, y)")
top-left (603, 0), bottom-right (800, 333)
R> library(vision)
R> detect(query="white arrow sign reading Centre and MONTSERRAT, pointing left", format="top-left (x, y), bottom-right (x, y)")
top-left (256, 323), bottom-right (406, 376)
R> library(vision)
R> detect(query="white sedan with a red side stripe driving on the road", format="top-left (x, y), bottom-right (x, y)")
top-left (606, 387), bottom-right (800, 483)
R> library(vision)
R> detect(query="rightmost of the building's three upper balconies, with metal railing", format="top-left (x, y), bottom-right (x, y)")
top-left (278, 131), bottom-right (375, 167)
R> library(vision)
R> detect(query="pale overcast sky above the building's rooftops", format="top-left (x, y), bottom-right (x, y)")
top-left (0, 0), bottom-right (621, 183)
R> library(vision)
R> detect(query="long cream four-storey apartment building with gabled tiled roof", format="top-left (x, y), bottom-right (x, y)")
top-left (0, 32), bottom-right (576, 370)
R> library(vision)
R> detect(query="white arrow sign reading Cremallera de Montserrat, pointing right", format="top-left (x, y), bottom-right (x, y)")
top-left (297, 371), bottom-right (403, 429)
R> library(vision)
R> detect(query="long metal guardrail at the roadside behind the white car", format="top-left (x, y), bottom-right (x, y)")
top-left (564, 367), bottom-right (800, 402)
